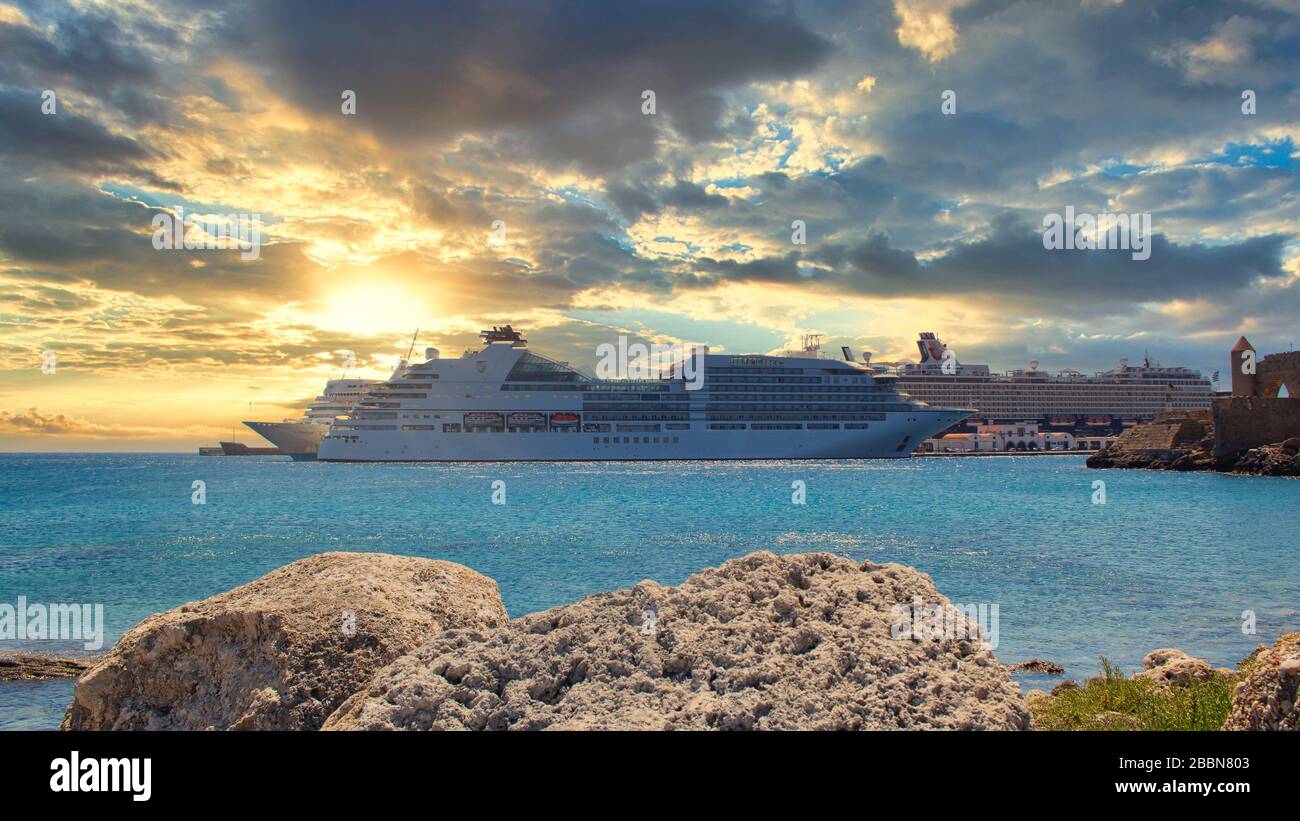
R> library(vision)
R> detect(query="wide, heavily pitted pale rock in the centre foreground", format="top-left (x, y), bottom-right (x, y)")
top-left (325, 552), bottom-right (1028, 730)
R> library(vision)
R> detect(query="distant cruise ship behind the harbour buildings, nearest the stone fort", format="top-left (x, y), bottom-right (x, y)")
top-left (878, 333), bottom-right (1214, 429)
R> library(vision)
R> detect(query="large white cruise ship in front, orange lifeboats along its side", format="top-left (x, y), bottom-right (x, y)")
top-left (319, 325), bottom-right (971, 461)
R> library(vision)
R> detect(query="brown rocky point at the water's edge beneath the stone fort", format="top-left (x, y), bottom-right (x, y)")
top-left (1086, 414), bottom-right (1300, 477)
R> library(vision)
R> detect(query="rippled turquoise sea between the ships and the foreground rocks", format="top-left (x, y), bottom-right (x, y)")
top-left (0, 453), bottom-right (1300, 729)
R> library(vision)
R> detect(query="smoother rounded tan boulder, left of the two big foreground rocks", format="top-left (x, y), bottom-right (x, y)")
top-left (64, 553), bottom-right (507, 730)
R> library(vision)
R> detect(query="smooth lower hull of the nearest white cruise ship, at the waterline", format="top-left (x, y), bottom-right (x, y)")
top-left (317, 409), bottom-right (967, 462)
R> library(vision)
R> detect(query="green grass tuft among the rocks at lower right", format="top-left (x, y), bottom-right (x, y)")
top-left (1030, 657), bottom-right (1240, 730)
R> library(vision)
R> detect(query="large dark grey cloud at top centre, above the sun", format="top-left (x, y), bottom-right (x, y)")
top-left (229, 0), bottom-right (831, 170)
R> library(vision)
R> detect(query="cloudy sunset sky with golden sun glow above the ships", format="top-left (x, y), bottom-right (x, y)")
top-left (0, 0), bottom-right (1300, 451)
